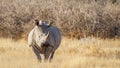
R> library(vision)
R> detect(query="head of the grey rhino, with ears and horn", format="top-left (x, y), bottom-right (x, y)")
top-left (34, 20), bottom-right (52, 47)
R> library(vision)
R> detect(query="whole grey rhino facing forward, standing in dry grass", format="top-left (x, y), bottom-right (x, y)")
top-left (28, 20), bottom-right (61, 61)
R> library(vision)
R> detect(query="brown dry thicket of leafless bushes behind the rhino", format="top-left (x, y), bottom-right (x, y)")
top-left (0, 0), bottom-right (120, 39)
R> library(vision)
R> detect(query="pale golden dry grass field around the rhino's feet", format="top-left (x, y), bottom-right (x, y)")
top-left (0, 38), bottom-right (120, 68)
